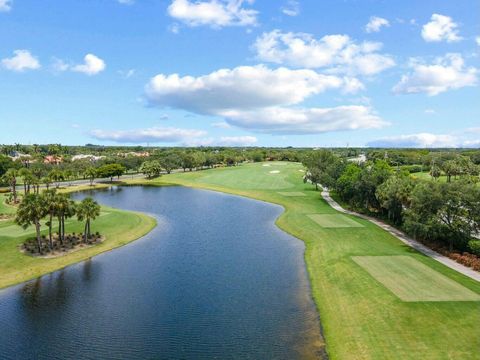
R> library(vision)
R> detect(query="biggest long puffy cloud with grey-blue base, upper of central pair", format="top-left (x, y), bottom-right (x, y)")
top-left (145, 65), bottom-right (358, 114)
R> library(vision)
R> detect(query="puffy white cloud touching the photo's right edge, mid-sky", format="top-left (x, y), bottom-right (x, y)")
top-left (393, 54), bottom-right (478, 96)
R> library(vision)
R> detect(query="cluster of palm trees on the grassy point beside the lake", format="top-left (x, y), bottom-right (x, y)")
top-left (15, 189), bottom-right (100, 254)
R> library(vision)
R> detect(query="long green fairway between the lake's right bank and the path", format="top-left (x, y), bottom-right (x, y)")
top-left (125, 163), bottom-right (480, 360)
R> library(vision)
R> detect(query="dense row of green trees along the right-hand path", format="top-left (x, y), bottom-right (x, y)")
top-left (303, 150), bottom-right (480, 269)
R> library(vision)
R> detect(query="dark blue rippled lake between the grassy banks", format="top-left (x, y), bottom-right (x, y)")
top-left (0, 187), bottom-right (321, 359)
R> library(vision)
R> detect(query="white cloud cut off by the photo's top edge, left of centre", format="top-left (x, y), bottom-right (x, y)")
top-left (168, 0), bottom-right (258, 28)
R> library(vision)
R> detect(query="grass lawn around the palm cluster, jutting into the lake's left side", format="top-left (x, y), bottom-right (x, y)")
top-left (0, 188), bottom-right (156, 289)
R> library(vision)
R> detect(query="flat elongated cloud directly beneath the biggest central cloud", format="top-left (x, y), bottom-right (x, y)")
top-left (221, 105), bottom-right (387, 134)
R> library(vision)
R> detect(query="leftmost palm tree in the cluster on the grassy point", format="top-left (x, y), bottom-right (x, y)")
top-left (15, 194), bottom-right (46, 254)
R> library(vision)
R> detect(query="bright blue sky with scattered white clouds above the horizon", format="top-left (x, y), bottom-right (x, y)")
top-left (0, 0), bottom-right (480, 147)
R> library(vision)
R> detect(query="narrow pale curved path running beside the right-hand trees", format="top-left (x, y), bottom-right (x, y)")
top-left (322, 187), bottom-right (480, 282)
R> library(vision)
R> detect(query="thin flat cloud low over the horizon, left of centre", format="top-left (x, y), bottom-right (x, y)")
top-left (90, 127), bottom-right (207, 144)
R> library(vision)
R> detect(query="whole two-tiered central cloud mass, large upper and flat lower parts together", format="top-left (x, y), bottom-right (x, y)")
top-left (145, 65), bottom-right (386, 134)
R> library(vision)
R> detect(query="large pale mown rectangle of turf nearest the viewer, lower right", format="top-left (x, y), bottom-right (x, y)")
top-left (352, 256), bottom-right (480, 302)
